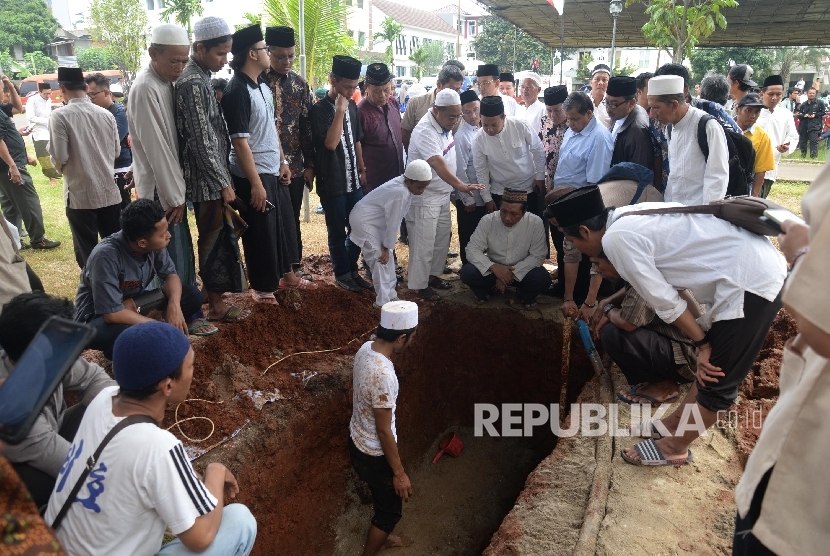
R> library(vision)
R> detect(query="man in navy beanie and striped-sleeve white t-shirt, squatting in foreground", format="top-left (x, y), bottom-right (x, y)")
top-left (44, 321), bottom-right (257, 556)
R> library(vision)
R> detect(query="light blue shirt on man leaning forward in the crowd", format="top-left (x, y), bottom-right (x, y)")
top-left (553, 118), bottom-right (614, 187)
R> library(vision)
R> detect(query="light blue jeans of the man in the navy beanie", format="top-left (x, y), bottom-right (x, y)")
top-left (156, 500), bottom-right (257, 556)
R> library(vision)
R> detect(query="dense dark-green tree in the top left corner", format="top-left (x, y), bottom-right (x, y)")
top-left (0, 0), bottom-right (59, 56)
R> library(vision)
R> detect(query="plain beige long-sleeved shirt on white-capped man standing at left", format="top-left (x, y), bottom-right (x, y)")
top-left (127, 64), bottom-right (187, 210)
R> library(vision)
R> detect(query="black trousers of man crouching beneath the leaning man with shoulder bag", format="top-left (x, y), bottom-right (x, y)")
top-left (601, 323), bottom-right (691, 386)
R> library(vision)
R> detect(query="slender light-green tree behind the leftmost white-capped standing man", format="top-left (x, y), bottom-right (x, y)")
top-left (88, 0), bottom-right (149, 86)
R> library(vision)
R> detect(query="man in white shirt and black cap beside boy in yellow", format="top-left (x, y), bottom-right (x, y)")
top-left (756, 75), bottom-right (798, 198)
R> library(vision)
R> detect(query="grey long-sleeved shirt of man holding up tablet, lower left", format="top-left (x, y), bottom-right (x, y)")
top-left (0, 352), bottom-right (116, 477)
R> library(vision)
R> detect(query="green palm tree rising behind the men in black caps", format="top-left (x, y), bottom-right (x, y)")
top-left (262, 0), bottom-right (356, 87)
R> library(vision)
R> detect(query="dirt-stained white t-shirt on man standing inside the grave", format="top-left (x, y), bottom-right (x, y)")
top-left (349, 342), bottom-right (398, 456)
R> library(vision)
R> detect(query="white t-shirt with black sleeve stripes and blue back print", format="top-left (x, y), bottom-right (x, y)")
top-left (45, 386), bottom-right (217, 556)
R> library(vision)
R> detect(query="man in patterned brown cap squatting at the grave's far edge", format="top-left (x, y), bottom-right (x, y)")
top-left (461, 189), bottom-right (551, 309)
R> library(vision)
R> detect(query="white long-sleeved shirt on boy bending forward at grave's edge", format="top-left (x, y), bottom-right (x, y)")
top-left (349, 176), bottom-right (413, 249)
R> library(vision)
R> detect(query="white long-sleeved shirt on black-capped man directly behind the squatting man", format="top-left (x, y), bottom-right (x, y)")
top-left (473, 117), bottom-right (545, 203)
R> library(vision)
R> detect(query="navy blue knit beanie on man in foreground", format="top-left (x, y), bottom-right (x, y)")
top-left (112, 321), bottom-right (190, 390)
